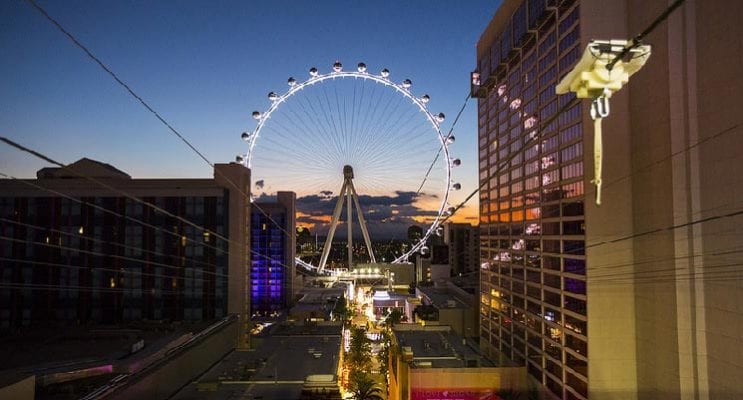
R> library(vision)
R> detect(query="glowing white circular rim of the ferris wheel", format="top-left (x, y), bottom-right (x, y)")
top-left (241, 68), bottom-right (454, 265)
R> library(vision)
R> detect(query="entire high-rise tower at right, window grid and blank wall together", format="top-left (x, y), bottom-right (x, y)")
top-left (473, 0), bottom-right (743, 399)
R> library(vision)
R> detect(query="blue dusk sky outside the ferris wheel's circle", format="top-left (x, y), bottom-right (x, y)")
top-left (0, 1), bottom-right (500, 238)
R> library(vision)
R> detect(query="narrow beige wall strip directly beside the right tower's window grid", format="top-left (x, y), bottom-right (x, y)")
top-left (580, 0), bottom-right (640, 400)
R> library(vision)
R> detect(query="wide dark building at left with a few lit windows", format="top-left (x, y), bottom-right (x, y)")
top-left (0, 159), bottom-right (250, 346)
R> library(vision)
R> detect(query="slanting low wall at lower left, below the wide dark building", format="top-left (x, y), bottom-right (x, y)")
top-left (110, 320), bottom-right (240, 400)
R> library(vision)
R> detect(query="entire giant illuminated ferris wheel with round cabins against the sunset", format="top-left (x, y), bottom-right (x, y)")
top-left (237, 62), bottom-right (461, 271)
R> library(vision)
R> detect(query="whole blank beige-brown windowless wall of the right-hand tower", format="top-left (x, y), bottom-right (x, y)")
top-left (581, 0), bottom-right (743, 399)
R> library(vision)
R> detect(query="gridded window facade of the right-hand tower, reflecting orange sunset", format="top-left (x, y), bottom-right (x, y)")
top-left (478, 1), bottom-right (588, 398)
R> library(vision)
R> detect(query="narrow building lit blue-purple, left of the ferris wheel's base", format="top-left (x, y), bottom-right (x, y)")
top-left (250, 192), bottom-right (298, 317)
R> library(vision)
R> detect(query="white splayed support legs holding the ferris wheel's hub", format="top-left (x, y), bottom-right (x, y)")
top-left (317, 165), bottom-right (377, 272)
